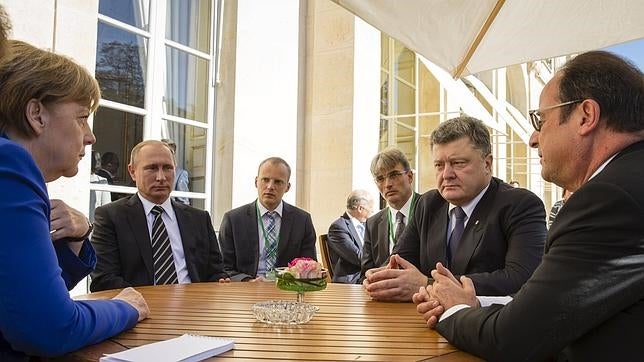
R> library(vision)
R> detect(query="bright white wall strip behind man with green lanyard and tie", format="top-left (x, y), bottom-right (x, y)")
top-left (232, 0), bottom-right (300, 208)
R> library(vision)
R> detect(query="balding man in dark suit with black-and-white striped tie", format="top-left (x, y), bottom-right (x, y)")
top-left (90, 140), bottom-right (227, 292)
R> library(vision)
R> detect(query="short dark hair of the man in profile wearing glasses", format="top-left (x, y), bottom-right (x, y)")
top-left (559, 51), bottom-right (644, 132)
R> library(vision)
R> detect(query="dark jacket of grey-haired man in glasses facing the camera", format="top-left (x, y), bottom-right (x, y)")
top-left (361, 192), bottom-right (420, 277)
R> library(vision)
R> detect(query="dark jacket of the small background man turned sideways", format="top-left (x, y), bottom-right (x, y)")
top-left (327, 212), bottom-right (362, 284)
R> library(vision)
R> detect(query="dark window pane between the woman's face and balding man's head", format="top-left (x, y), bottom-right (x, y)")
top-left (92, 107), bottom-right (143, 188)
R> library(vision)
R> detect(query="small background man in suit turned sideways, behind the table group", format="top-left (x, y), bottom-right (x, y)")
top-left (327, 190), bottom-right (373, 284)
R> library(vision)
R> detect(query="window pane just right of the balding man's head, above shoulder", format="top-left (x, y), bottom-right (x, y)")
top-left (161, 120), bottom-right (208, 195)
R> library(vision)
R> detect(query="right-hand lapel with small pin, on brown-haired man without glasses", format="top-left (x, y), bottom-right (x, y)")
top-left (452, 178), bottom-right (499, 274)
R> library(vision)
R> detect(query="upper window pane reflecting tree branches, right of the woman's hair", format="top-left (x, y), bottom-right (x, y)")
top-left (96, 22), bottom-right (147, 108)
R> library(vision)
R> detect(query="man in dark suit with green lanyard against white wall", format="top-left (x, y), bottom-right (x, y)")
top-left (219, 157), bottom-right (317, 281)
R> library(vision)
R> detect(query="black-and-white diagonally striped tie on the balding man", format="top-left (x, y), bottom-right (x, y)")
top-left (151, 206), bottom-right (178, 285)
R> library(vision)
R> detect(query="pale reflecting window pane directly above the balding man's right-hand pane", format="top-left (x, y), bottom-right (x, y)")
top-left (164, 47), bottom-right (208, 122)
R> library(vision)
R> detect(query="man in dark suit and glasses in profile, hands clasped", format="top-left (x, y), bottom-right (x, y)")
top-left (414, 51), bottom-right (644, 361)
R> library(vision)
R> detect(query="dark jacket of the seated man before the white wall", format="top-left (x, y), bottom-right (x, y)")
top-left (219, 201), bottom-right (317, 281)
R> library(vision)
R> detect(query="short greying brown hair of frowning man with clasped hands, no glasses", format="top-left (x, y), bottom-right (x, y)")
top-left (429, 116), bottom-right (492, 157)
